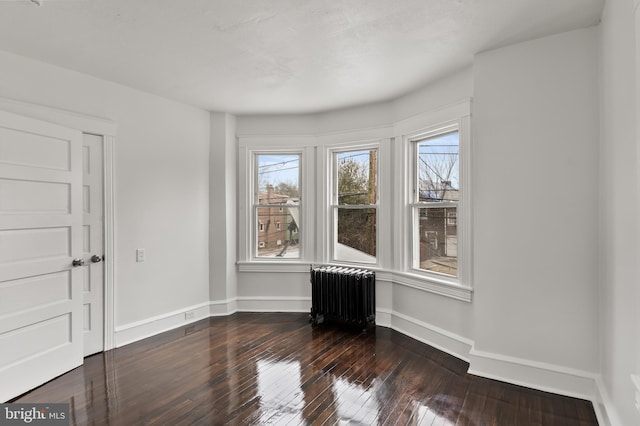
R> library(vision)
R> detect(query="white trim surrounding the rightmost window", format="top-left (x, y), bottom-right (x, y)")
top-left (398, 109), bottom-right (472, 292)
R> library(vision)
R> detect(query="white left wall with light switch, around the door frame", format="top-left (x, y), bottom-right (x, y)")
top-left (0, 52), bottom-right (209, 331)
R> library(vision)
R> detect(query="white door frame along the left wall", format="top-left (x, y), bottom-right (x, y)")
top-left (0, 97), bottom-right (117, 351)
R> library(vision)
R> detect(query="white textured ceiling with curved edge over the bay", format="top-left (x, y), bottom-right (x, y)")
top-left (0, 0), bottom-right (604, 114)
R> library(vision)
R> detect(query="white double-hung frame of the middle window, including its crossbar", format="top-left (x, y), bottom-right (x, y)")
top-left (326, 141), bottom-right (383, 268)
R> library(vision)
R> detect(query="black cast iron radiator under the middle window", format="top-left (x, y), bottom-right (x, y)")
top-left (310, 266), bottom-right (376, 329)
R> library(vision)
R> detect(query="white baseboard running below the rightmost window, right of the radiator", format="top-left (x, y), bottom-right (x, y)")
top-left (391, 312), bottom-right (473, 362)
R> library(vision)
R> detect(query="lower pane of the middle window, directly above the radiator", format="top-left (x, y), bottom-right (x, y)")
top-left (335, 208), bottom-right (376, 263)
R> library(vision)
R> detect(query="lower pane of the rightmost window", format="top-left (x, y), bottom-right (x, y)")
top-left (418, 207), bottom-right (458, 276)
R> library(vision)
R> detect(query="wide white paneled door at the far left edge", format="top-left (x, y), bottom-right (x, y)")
top-left (0, 111), bottom-right (83, 402)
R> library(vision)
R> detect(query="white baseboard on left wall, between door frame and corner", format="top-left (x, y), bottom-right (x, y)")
top-left (114, 302), bottom-right (210, 348)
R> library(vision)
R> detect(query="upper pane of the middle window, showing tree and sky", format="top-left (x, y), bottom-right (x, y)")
top-left (336, 149), bottom-right (378, 205)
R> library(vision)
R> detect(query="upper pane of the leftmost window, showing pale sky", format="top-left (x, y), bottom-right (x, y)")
top-left (256, 154), bottom-right (300, 204)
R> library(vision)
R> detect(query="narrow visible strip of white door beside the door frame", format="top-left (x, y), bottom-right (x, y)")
top-left (82, 134), bottom-right (104, 356)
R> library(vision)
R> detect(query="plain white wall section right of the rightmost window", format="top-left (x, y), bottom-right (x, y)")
top-left (473, 28), bottom-right (599, 381)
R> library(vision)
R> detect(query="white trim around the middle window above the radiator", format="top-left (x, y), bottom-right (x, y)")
top-left (324, 140), bottom-right (383, 268)
